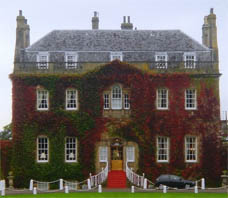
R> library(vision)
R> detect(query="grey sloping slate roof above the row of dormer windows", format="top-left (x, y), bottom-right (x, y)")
top-left (27, 30), bottom-right (209, 52)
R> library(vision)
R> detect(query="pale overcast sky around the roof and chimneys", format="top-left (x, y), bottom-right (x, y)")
top-left (0, 0), bottom-right (228, 130)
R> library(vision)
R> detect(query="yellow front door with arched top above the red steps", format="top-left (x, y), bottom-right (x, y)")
top-left (111, 138), bottom-right (123, 170)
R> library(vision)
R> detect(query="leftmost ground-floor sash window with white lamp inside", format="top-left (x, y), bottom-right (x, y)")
top-left (37, 137), bottom-right (49, 162)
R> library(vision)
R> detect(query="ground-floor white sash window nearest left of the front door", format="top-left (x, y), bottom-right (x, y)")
top-left (65, 137), bottom-right (77, 162)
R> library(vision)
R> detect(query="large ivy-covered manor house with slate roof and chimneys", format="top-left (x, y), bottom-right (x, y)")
top-left (0, 9), bottom-right (224, 187)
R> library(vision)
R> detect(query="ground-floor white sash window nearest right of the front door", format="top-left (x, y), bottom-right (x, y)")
top-left (157, 137), bottom-right (169, 162)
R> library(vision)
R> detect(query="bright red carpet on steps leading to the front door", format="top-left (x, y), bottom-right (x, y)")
top-left (107, 171), bottom-right (126, 188)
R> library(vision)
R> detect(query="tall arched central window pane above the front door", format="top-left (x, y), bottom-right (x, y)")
top-left (112, 85), bottom-right (122, 109)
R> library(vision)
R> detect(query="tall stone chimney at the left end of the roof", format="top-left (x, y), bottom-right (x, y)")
top-left (14, 10), bottom-right (30, 62)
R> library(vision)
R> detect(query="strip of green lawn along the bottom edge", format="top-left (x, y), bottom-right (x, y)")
top-left (5, 192), bottom-right (228, 198)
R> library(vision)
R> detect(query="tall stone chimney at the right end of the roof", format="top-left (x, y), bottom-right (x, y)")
top-left (202, 8), bottom-right (218, 61)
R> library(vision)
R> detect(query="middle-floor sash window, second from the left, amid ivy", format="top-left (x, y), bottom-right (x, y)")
top-left (66, 89), bottom-right (78, 110)
